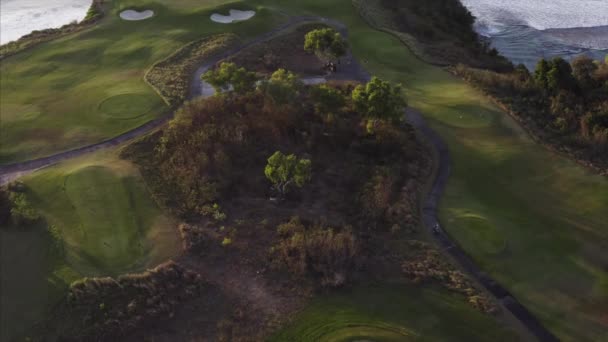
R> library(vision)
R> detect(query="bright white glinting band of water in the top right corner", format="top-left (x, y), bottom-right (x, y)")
top-left (461, 0), bottom-right (608, 35)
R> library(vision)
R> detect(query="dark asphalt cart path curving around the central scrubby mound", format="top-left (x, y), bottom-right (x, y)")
top-left (0, 12), bottom-right (559, 342)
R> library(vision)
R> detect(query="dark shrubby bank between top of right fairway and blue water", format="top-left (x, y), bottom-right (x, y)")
top-left (353, 0), bottom-right (512, 70)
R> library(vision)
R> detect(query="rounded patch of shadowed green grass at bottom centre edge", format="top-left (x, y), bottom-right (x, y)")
top-left (270, 285), bottom-right (517, 342)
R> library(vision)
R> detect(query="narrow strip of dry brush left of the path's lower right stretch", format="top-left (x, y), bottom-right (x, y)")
top-left (401, 241), bottom-right (497, 313)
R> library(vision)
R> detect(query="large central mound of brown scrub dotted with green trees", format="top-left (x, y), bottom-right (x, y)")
top-left (126, 63), bottom-right (428, 286)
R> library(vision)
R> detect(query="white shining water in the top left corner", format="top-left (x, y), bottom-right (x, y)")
top-left (0, 0), bottom-right (91, 44)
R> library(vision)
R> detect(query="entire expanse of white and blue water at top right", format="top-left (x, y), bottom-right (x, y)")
top-left (461, 0), bottom-right (608, 69)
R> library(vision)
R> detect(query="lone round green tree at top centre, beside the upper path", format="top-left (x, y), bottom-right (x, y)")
top-left (304, 28), bottom-right (348, 61)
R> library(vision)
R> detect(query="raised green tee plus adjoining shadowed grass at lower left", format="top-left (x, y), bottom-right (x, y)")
top-left (0, 153), bottom-right (179, 336)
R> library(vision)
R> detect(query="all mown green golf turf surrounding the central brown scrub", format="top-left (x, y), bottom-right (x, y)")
top-left (0, 0), bottom-right (608, 341)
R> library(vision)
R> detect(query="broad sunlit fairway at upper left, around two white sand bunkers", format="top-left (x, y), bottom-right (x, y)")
top-left (0, 0), bottom-right (283, 164)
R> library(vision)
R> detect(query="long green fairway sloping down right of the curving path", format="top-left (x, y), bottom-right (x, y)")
top-left (255, 0), bottom-right (608, 341)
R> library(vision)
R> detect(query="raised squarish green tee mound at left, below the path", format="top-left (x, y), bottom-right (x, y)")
top-left (25, 152), bottom-right (178, 275)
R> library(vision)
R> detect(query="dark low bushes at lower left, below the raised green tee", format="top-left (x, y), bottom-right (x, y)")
top-left (50, 261), bottom-right (204, 340)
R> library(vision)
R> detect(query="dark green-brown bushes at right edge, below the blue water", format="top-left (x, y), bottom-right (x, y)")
top-left (455, 56), bottom-right (608, 171)
